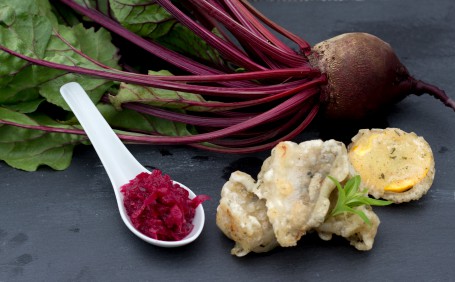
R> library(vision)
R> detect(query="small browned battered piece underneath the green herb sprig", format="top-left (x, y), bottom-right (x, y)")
top-left (315, 206), bottom-right (380, 251)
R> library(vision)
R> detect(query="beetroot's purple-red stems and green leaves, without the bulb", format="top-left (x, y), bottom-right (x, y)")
top-left (0, 0), bottom-right (454, 170)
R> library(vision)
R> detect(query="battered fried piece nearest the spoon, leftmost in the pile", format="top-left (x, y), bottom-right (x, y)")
top-left (216, 171), bottom-right (278, 257)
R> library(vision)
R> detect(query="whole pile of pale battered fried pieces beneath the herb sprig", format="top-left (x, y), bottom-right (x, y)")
top-left (216, 140), bottom-right (388, 256)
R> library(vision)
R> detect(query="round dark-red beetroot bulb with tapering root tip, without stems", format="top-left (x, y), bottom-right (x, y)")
top-left (310, 33), bottom-right (455, 119)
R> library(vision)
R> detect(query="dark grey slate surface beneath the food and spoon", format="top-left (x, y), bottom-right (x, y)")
top-left (0, 0), bottom-right (455, 282)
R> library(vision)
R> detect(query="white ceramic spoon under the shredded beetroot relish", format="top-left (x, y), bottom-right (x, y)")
top-left (60, 82), bottom-right (205, 247)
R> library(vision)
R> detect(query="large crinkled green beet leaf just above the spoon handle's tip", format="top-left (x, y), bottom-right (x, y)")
top-left (0, 0), bottom-right (119, 110)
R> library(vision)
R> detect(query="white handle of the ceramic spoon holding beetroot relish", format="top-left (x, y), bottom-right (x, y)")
top-left (60, 82), bottom-right (147, 193)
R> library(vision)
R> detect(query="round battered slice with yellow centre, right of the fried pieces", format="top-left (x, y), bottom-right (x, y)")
top-left (348, 128), bottom-right (435, 203)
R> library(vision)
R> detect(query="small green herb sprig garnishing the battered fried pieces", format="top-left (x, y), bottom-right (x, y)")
top-left (328, 175), bottom-right (392, 225)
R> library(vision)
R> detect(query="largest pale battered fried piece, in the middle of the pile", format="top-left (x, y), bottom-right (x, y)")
top-left (252, 140), bottom-right (349, 247)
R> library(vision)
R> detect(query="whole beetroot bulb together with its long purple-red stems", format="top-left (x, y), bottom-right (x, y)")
top-left (0, 0), bottom-right (455, 153)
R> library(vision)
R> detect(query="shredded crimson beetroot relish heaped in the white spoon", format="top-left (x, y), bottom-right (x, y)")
top-left (120, 170), bottom-right (209, 241)
